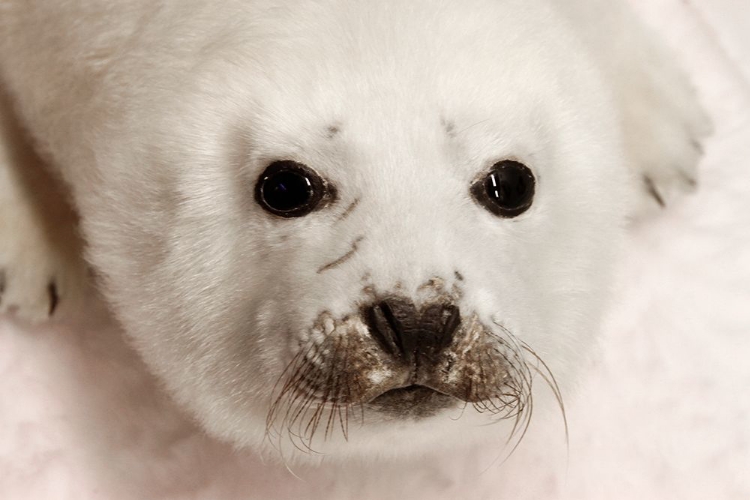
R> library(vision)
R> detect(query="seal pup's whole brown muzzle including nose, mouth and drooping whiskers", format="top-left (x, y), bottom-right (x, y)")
top-left (266, 272), bottom-right (564, 450)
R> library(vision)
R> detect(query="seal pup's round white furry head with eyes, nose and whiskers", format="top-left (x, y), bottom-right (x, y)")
top-left (84, 1), bottom-right (627, 460)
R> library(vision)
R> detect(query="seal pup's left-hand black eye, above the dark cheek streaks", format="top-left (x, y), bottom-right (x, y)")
top-left (255, 160), bottom-right (325, 217)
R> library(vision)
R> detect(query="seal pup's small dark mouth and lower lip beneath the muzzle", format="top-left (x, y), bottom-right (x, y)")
top-left (367, 384), bottom-right (459, 419)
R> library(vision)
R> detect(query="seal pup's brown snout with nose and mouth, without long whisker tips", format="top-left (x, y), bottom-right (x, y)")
top-left (280, 300), bottom-right (530, 419)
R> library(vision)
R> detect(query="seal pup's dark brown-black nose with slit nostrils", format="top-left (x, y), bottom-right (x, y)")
top-left (365, 297), bottom-right (461, 363)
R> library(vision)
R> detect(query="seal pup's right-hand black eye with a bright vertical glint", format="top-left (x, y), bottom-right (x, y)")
top-left (471, 160), bottom-right (535, 218)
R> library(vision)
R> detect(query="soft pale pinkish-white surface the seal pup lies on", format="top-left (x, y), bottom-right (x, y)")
top-left (0, 0), bottom-right (750, 500)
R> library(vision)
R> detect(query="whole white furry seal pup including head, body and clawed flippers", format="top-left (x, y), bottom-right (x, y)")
top-left (0, 0), bottom-right (705, 456)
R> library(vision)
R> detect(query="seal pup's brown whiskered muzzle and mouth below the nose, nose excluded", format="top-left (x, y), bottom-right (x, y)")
top-left (266, 308), bottom-right (565, 451)
